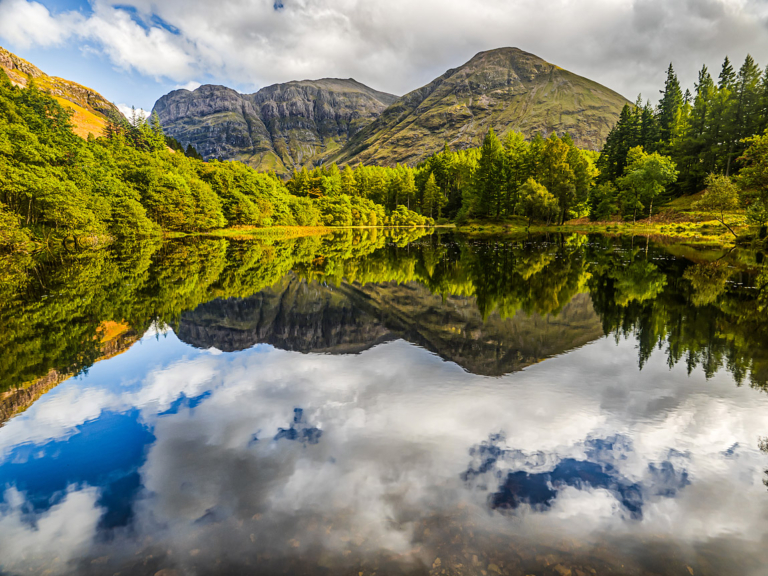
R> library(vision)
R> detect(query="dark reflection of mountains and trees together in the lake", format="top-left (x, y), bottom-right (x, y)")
top-left (0, 230), bottom-right (768, 410)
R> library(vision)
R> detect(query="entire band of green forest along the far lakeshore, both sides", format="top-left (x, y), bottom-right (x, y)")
top-left (0, 56), bottom-right (768, 250)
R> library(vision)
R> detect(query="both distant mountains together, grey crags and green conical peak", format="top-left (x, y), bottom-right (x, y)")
top-left (154, 48), bottom-right (628, 174)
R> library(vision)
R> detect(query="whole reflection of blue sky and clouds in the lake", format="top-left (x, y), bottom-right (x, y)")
top-left (0, 322), bottom-right (768, 576)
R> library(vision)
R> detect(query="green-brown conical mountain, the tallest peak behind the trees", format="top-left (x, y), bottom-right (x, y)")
top-left (325, 48), bottom-right (628, 166)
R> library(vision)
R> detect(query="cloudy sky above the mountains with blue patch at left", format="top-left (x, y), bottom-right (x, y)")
top-left (0, 0), bottom-right (768, 115)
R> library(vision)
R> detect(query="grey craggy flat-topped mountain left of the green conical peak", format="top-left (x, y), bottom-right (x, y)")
top-left (153, 78), bottom-right (397, 174)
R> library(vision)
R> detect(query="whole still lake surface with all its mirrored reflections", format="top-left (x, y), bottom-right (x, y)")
top-left (0, 231), bottom-right (768, 576)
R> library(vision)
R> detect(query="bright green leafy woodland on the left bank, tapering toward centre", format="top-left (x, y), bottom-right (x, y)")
top-left (0, 71), bottom-right (431, 247)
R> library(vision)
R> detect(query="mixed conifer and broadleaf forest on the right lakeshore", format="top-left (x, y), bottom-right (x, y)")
top-left (288, 56), bottom-right (768, 232)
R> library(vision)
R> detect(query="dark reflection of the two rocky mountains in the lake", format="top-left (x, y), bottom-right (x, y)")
top-left (177, 274), bottom-right (603, 376)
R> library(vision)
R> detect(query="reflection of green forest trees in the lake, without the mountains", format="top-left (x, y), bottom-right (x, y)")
top-left (6, 228), bottom-right (768, 400)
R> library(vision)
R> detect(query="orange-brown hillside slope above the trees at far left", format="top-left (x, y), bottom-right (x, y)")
top-left (0, 47), bottom-right (120, 138)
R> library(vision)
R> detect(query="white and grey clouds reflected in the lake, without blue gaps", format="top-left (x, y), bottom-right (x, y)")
top-left (0, 334), bottom-right (768, 576)
